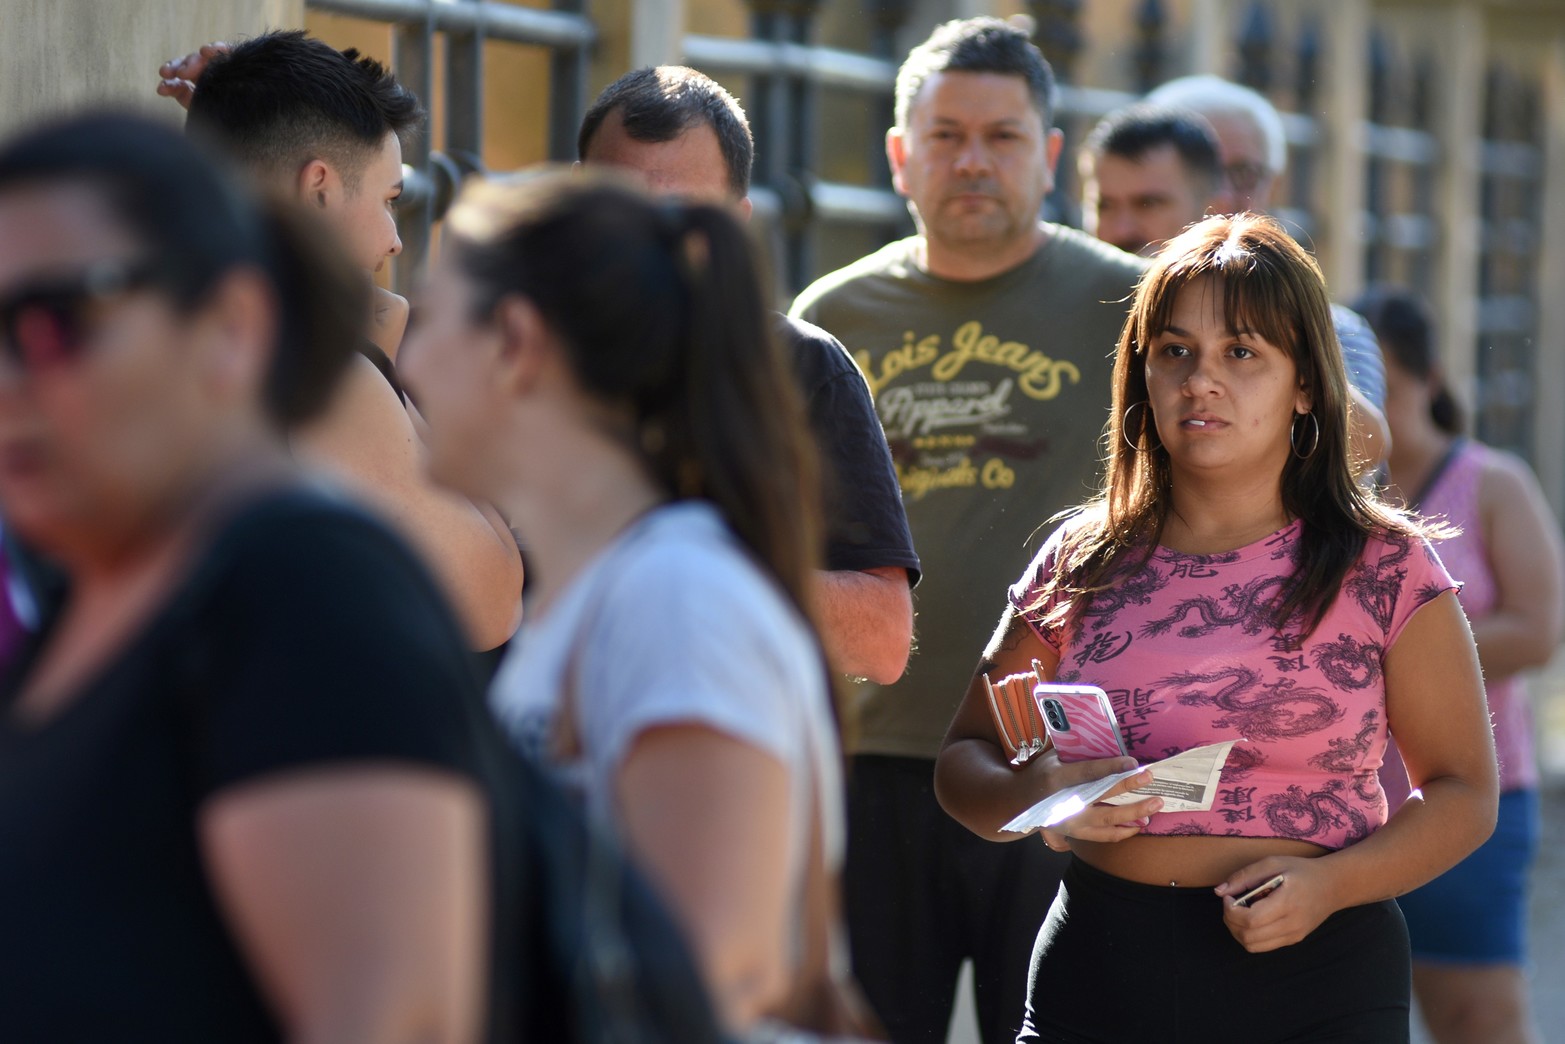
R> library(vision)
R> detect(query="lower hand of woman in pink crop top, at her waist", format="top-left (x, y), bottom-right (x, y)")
top-left (1213, 856), bottom-right (1338, 953)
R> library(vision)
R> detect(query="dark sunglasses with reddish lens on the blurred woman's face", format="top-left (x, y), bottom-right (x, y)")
top-left (0, 260), bottom-right (157, 369)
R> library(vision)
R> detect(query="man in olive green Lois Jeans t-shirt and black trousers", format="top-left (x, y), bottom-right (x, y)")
top-left (793, 19), bottom-right (1141, 1044)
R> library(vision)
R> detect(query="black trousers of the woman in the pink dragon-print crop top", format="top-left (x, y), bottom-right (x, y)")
top-left (1017, 859), bottom-right (1412, 1044)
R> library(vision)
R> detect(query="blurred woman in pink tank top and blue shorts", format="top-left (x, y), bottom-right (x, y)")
top-left (1358, 290), bottom-right (1565, 1044)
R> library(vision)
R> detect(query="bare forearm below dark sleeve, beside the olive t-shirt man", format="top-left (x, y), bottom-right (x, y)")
top-left (815, 567), bottom-right (912, 686)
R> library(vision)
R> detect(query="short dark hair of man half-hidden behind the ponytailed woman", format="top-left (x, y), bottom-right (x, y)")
top-left (576, 66), bottom-right (756, 199)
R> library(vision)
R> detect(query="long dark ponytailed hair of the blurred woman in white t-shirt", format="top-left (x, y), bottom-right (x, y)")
top-left (446, 174), bottom-right (822, 618)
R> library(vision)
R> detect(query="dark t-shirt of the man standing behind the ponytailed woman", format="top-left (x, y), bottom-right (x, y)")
top-left (778, 316), bottom-right (920, 585)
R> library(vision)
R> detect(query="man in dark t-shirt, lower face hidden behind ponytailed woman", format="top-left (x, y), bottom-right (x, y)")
top-left (577, 66), bottom-right (920, 684)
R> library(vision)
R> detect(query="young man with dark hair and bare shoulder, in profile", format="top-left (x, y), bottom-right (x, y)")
top-left (158, 31), bottom-right (521, 651)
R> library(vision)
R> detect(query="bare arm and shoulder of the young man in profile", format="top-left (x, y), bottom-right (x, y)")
top-left (293, 355), bottom-right (521, 650)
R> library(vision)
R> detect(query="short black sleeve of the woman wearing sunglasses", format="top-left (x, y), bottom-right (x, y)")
top-left (182, 501), bottom-right (484, 794)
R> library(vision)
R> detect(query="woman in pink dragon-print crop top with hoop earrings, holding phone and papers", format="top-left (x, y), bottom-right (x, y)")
top-left (936, 214), bottom-right (1496, 1042)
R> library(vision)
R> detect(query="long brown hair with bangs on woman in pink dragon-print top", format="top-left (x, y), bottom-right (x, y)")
top-left (1038, 214), bottom-right (1423, 632)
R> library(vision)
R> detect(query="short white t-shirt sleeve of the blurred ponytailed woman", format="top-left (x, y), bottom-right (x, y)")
top-left (574, 546), bottom-right (826, 779)
